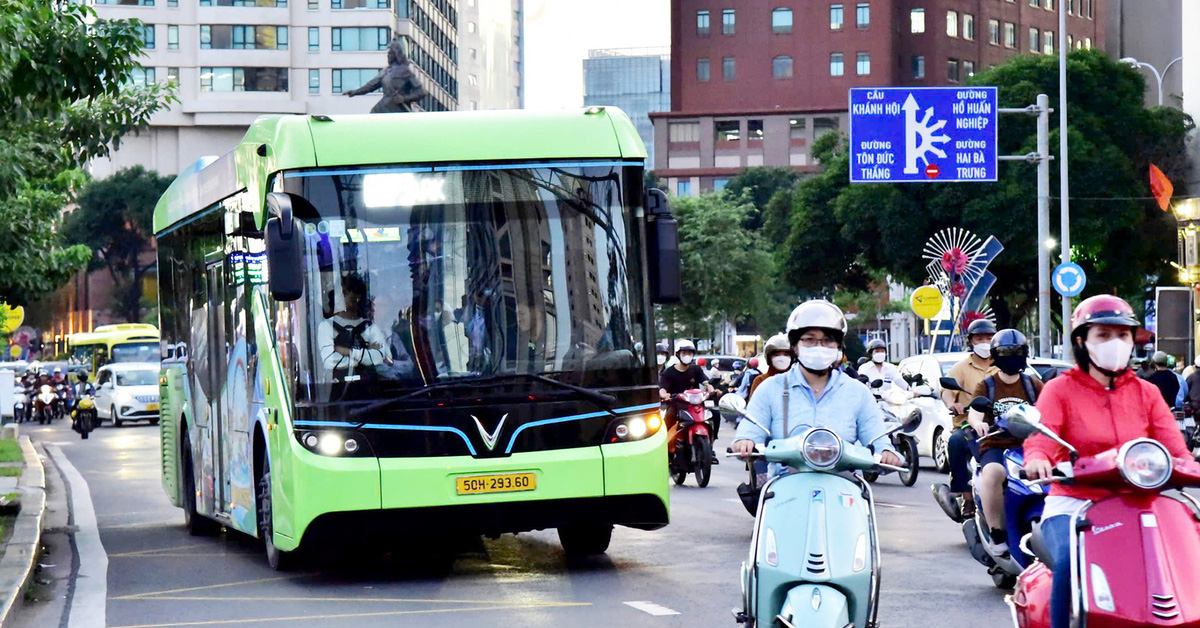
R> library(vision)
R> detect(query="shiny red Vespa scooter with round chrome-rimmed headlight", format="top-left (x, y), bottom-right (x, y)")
top-left (1007, 407), bottom-right (1200, 628)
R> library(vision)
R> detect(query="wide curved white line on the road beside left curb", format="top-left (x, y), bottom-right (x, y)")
top-left (46, 444), bottom-right (108, 628)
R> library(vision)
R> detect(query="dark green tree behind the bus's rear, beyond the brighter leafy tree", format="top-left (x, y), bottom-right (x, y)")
top-left (62, 166), bottom-right (173, 323)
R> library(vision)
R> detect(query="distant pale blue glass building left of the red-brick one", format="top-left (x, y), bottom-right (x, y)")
top-left (583, 48), bottom-right (671, 163)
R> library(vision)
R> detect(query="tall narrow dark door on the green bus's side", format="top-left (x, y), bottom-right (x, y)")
top-left (204, 252), bottom-right (230, 514)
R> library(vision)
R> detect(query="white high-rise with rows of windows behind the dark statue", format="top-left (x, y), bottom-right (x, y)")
top-left (92, 0), bottom-right (463, 177)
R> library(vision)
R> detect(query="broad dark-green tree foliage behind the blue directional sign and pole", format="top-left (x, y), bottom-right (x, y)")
top-left (766, 50), bottom-right (1193, 324)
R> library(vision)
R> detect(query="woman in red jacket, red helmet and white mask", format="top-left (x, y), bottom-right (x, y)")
top-left (1025, 294), bottom-right (1190, 628)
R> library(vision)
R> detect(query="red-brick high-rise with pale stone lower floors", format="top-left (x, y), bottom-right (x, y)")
top-left (650, 0), bottom-right (1106, 196)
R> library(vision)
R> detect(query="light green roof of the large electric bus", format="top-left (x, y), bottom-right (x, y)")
top-left (154, 107), bottom-right (646, 233)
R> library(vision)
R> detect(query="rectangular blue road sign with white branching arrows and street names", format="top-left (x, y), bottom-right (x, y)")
top-left (850, 88), bottom-right (997, 183)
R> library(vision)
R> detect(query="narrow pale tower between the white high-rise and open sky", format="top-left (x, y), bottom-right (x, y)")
top-left (458, 0), bottom-right (524, 110)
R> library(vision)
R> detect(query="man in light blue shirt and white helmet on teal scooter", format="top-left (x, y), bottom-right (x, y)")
top-left (732, 299), bottom-right (902, 473)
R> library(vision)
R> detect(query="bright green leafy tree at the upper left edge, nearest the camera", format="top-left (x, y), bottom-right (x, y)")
top-left (0, 0), bottom-right (170, 304)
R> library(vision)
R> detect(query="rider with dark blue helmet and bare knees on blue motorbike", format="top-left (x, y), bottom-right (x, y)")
top-left (967, 329), bottom-right (1042, 556)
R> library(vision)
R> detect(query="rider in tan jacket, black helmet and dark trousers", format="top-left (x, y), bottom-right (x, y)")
top-left (934, 318), bottom-right (996, 521)
